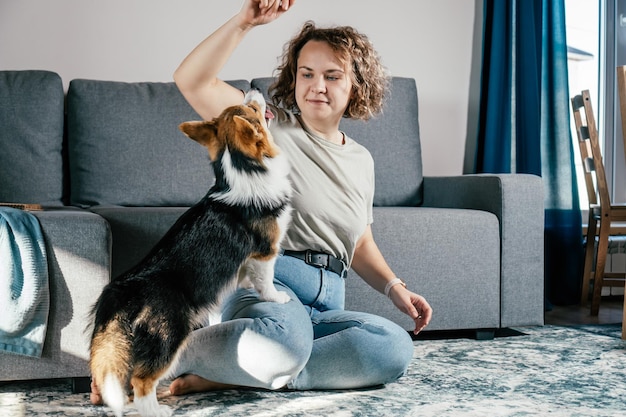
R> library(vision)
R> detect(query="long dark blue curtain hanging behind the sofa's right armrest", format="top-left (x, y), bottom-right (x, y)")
top-left (476, 0), bottom-right (583, 304)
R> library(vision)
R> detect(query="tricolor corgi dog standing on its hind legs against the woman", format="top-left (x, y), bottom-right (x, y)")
top-left (89, 90), bottom-right (291, 417)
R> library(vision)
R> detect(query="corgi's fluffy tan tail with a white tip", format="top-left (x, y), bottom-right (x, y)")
top-left (89, 320), bottom-right (131, 417)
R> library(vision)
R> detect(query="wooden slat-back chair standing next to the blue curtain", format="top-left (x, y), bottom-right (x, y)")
top-left (571, 90), bottom-right (626, 316)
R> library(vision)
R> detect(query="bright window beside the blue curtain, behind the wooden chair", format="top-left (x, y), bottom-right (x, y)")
top-left (565, 0), bottom-right (626, 210)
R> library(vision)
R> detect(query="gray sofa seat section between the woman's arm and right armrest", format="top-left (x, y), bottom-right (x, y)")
top-left (346, 207), bottom-right (501, 330)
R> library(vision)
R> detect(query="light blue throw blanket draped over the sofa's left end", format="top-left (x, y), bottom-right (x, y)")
top-left (0, 207), bottom-right (50, 357)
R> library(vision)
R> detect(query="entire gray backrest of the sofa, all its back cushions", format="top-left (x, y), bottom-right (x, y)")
top-left (0, 71), bottom-right (422, 206)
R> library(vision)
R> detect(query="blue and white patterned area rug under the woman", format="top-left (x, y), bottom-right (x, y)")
top-left (0, 325), bottom-right (626, 417)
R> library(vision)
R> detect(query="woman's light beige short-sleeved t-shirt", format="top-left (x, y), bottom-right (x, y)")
top-left (270, 106), bottom-right (374, 265)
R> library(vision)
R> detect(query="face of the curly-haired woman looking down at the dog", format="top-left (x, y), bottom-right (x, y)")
top-left (295, 41), bottom-right (352, 128)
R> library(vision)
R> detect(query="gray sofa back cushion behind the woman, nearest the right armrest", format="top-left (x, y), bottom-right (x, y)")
top-left (251, 77), bottom-right (423, 206)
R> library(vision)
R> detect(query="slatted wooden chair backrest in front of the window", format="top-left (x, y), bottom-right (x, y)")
top-left (571, 90), bottom-right (611, 212)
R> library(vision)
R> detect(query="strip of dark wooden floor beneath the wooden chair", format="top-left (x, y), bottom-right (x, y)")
top-left (545, 297), bottom-right (624, 326)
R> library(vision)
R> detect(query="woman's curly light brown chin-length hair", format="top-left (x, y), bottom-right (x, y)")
top-left (270, 21), bottom-right (389, 120)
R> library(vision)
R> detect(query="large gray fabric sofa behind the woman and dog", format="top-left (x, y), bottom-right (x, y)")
top-left (0, 71), bottom-right (544, 386)
